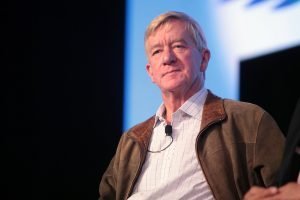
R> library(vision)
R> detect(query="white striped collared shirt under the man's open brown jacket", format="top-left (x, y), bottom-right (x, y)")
top-left (129, 88), bottom-right (214, 200)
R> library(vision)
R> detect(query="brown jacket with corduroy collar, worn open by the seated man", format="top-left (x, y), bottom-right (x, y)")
top-left (99, 91), bottom-right (285, 200)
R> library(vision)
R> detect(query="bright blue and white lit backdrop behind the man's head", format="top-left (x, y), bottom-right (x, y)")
top-left (123, 0), bottom-right (300, 131)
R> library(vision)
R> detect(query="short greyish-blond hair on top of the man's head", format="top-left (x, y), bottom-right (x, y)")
top-left (144, 11), bottom-right (207, 51)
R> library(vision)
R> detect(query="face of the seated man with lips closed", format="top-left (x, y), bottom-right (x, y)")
top-left (146, 20), bottom-right (209, 92)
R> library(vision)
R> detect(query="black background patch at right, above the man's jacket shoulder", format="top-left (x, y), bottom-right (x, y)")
top-left (240, 46), bottom-right (300, 135)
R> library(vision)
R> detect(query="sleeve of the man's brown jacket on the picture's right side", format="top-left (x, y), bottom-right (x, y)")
top-left (254, 112), bottom-right (285, 187)
